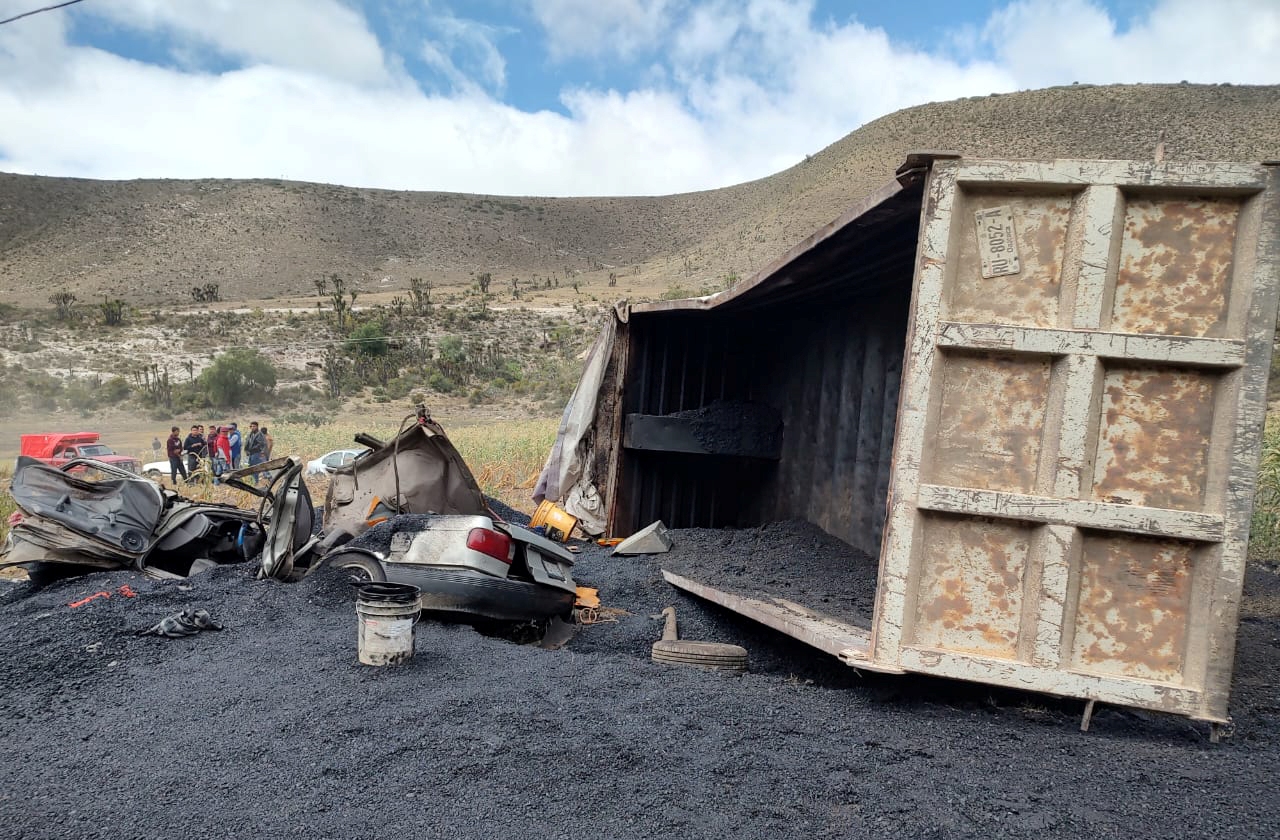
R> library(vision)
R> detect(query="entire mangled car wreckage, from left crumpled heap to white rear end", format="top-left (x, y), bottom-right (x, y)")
top-left (0, 406), bottom-right (577, 622)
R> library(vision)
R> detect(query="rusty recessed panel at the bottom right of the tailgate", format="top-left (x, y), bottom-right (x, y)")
top-left (1071, 534), bottom-right (1194, 683)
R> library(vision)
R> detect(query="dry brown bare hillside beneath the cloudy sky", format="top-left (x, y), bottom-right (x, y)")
top-left (0, 85), bottom-right (1280, 306)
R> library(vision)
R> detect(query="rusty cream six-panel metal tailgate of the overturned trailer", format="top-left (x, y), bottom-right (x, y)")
top-left (872, 160), bottom-right (1280, 721)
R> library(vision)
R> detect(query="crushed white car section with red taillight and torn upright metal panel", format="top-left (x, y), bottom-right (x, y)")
top-left (248, 406), bottom-right (577, 621)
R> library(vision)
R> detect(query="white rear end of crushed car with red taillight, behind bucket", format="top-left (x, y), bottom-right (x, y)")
top-left (324, 515), bottom-right (577, 621)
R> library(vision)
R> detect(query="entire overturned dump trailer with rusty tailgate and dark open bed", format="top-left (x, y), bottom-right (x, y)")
top-left (544, 152), bottom-right (1280, 722)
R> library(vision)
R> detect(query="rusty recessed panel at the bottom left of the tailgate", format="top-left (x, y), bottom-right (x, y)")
top-left (914, 515), bottom-right (1033, 658)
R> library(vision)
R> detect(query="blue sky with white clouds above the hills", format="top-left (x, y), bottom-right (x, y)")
top-left (0, 0), bottom-right (1280, 196)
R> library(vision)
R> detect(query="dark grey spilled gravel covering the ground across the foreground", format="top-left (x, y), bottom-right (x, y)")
top-left (0, 514), bottom-right (1280, 840)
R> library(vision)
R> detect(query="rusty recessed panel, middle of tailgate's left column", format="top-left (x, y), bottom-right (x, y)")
top-left (927, 353), bottom-right (1050, 493)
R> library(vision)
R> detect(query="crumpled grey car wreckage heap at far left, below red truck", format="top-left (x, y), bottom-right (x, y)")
top-left (0, 456), bottom-right (265, 580)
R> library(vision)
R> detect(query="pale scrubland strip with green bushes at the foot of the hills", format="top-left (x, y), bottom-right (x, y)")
top-left (0, 281), bottom-right (600, 420)
